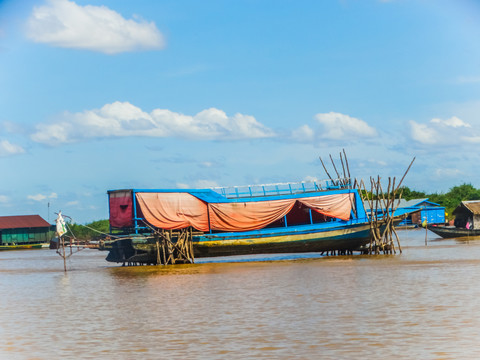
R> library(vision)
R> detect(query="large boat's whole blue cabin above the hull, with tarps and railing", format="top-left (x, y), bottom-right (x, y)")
top-left (108, 182), bottom-right (367, 234)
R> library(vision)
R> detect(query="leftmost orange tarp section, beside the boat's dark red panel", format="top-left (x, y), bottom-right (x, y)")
top-left (136, 193), bottom-right (209, 231)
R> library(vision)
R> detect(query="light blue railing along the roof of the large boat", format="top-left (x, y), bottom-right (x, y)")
top-left (212, 179), bottom-right (351, 199)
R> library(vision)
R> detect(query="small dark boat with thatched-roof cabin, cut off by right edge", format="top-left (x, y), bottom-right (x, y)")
top-left (426, 200), bottom-right (480, 238)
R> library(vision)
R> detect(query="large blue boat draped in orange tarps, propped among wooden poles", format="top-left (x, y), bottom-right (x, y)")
top-left (99, 181), bottom-right (408, 264)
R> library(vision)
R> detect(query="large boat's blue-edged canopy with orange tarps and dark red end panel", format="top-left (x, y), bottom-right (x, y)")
top-left (108, 189), bottom-right (356, 231)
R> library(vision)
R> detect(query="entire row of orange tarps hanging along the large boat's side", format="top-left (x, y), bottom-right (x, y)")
top-left (136, 192), bottom-right (353, 231)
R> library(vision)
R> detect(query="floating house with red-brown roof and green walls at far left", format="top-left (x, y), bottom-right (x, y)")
top-left (0, 215), bottom-right (51, 245)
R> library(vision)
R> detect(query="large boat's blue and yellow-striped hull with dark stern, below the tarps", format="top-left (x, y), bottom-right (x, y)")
top-left (106, 222), bottom-right (370, 264)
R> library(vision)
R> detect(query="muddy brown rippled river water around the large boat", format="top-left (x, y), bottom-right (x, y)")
top-left (0, 229), bottom-right (480, 359)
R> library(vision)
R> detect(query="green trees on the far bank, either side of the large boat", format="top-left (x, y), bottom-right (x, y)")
top-left (67, 184), bottom-right (480, 240)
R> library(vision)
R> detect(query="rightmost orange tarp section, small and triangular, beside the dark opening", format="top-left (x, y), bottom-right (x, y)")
top-left (298, 194), bottom-right (353, 220)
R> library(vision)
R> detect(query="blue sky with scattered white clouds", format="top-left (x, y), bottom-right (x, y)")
top-left (0, 0), bottom-right (480, 223)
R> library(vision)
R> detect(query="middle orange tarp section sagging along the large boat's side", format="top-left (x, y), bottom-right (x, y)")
top-left (208, 199), bottom-right (296, 231)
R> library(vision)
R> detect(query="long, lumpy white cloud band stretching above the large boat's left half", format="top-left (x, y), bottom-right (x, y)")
top-left (31, 101), bottom-right (274, 145)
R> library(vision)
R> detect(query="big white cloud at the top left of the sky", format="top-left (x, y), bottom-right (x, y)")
top-left (27, 0), bottom-right (165, 54)
